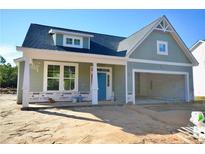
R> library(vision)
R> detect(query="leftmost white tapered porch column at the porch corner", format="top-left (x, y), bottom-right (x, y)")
top-left (22, 57), bottom-right (30, 108)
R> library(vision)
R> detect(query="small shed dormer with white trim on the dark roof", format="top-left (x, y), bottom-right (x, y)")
top-left (49, 29), bottom-right (93, 49)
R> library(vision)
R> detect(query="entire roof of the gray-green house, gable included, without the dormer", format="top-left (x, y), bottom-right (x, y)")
top-left (22, 16), bottom-right (198, 65)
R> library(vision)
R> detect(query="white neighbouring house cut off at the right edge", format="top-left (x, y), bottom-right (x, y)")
top-left (190, 40), bottom-right (205, 97)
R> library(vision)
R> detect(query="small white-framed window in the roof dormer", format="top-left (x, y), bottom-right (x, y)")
top-left (63, 35), bottom-right (83, 48)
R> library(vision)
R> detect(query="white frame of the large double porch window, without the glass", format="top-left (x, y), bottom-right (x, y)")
top-left (43, 61), bottom-right (78, 92)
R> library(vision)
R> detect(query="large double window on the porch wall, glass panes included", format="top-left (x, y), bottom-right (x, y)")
top-left (44, 62), bottom-right (78, 91)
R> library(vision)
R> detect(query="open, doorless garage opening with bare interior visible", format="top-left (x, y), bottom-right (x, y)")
top-left (133, 70), bottom-right (189, 104)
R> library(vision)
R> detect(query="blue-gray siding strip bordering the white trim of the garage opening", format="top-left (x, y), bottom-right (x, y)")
top-left (127, 62), bottom-right (193, 100)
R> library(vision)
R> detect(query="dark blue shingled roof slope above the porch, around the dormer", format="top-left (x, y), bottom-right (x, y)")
top-left (22, 24), bottom-right (126, 57)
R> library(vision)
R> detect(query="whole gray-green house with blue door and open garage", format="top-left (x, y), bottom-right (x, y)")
top-left (15, 16), bottom-right (198, 107)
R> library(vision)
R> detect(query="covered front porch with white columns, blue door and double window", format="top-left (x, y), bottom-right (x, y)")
top-left (15, 50), bottom-right (125, 108)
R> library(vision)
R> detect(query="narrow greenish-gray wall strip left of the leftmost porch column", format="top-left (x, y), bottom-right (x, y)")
top-left (17, 62), bottom-right (24, 104)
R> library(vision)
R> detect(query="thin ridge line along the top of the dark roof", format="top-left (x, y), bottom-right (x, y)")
top-left (31, 23), bottom-right (126, 38)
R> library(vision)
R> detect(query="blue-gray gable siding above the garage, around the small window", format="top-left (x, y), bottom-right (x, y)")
top-left (130, 31), bottom-right (190, 63)
